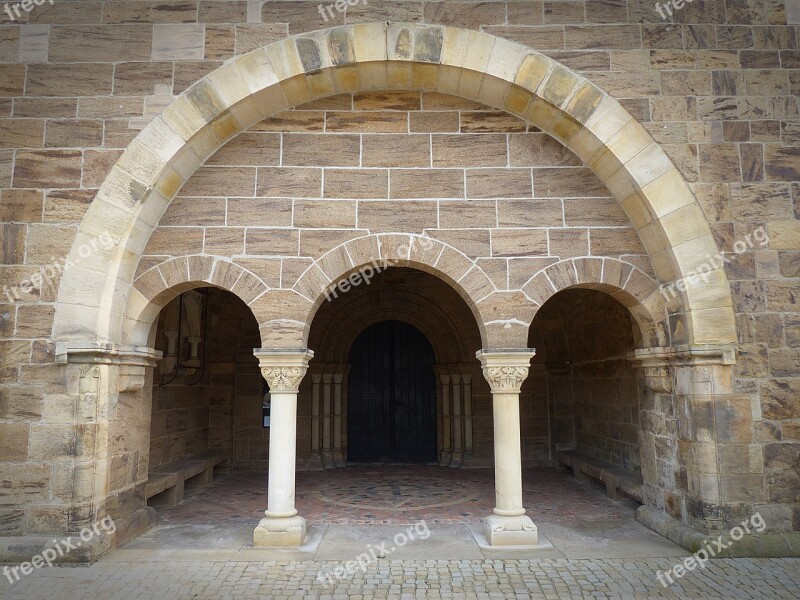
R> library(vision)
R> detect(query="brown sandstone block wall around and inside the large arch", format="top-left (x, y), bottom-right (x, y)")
top-left (0, 0), bottom-right (800, 535)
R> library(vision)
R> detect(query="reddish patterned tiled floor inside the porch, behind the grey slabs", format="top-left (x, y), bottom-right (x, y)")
top-left (153, 465), bottom-right (632, 525)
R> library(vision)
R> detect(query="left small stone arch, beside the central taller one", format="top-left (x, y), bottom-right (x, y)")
top-left (124, 254), bottom-right (270, 346)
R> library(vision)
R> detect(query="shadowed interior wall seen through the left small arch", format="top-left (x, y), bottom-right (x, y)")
top-left (149, 288), bottom-right (260, 470)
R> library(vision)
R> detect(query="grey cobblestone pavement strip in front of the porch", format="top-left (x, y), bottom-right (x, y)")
top-left (0, 558), bottom-right (800, 600)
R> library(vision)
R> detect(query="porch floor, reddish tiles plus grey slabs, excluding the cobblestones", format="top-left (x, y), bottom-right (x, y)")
top-left (115, 465), bottom-right (687, 561)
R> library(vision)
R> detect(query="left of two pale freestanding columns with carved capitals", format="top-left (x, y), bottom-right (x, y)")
top-left (253, 348), bottom-right (314, 546)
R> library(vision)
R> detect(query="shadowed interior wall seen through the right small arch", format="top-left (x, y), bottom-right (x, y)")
top-left (527, 290), bottom-right (646, 471)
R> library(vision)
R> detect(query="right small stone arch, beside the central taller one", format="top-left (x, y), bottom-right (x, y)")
top-left (522, 257), bottom-right (670, 348)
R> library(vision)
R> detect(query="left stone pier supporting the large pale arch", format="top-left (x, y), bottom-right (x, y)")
top-left (52, 341), bottom-right (161, 560)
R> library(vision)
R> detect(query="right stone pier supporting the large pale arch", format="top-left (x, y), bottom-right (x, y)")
top-left (629, 345), bottom-right (736, 533)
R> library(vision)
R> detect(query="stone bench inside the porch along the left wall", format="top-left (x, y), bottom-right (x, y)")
top-left (144, 450), bottom-right (227, 506)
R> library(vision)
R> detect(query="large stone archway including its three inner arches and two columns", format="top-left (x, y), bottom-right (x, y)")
top-left (40, 23), bottom-right (748, 556)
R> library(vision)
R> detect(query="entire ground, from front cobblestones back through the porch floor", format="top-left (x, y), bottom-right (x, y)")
top-left (0, 466), bottom-right (800, 600)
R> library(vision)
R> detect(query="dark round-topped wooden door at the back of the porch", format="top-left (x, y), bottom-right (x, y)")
top-left (347, 321), bottom-right (437, 463)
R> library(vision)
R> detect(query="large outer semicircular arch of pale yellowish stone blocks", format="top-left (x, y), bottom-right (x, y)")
top-left (53, 22), bottom-right (736, 352)
